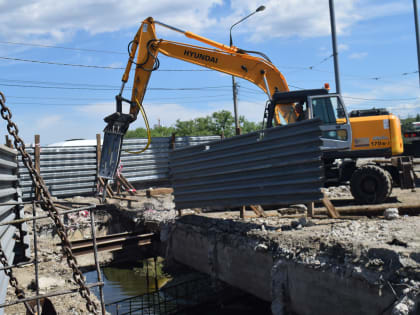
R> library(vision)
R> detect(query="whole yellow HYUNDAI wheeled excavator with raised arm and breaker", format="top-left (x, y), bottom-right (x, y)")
top-left (100, 17), bottom-right (415, 203)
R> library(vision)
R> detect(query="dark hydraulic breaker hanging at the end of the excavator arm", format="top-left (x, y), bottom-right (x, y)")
top-left (99, 95), bottom-right (135, 179)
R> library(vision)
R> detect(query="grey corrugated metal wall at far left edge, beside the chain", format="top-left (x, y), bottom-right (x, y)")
top-left (0, 145), bottom-right (30, 315)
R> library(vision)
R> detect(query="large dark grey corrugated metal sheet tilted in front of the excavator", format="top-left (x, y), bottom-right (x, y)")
top-left (170, 120), bottom-right (323, 209)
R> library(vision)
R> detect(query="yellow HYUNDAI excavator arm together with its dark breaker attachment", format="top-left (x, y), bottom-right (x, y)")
top-left (99, 17), bottom-right (297, 179)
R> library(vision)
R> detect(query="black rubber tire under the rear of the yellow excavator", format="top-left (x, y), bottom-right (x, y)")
top-left (350, 164), bottom-right (392, 204)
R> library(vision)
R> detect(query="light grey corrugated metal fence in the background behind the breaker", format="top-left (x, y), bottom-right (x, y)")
top-left (19, 136), bottom-right (220, 200)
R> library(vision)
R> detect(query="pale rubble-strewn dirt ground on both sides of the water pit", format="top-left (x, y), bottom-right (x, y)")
top-left (5, 174), bottom-right (420, 315)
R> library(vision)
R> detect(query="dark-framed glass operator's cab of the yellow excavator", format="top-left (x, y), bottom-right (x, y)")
top-left (267, 89), bottom-right (352, 151)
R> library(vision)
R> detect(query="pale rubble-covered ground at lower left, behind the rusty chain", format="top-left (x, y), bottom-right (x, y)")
top-left (5, 201), bottom-right (111, 315)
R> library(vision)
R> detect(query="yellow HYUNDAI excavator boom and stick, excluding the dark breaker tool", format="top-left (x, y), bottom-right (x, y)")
top-left (122, 18), bottom-right (296, 123)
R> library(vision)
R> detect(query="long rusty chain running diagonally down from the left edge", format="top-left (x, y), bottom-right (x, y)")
top-left (0, 92), bottom-right (98, 314)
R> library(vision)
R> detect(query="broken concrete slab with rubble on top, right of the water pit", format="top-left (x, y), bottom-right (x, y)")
top-left (5, 187), bottom-right (420, 314)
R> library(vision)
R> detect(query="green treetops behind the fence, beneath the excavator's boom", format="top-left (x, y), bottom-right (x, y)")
top-left (125, 110), bottom-right (261, 138)
